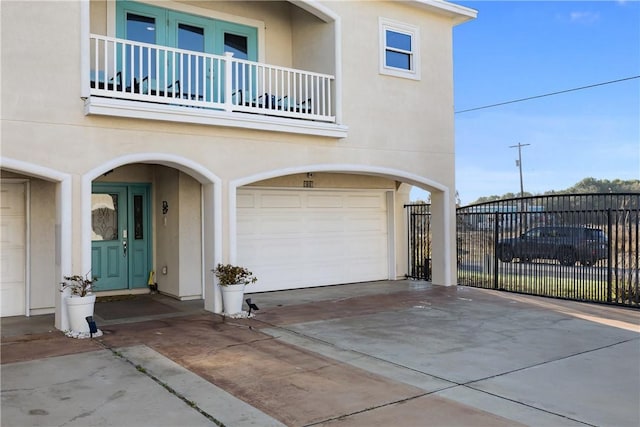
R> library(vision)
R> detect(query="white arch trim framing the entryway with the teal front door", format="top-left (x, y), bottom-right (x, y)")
top-left (80, 153), bottom-right (222, 313)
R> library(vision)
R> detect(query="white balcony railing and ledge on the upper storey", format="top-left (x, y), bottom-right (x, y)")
top-left (85, 34), bottom-right (346, 137)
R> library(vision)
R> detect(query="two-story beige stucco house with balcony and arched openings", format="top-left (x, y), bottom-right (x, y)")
top-left (0, 0), bottom-right (476, 329)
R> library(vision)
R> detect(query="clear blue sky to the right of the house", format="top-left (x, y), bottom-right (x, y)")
top-left (412, 1), bottom-right (640, 205)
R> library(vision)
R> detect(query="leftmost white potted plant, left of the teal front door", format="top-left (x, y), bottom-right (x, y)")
top-left (60, 273), bottom-right (98, 334)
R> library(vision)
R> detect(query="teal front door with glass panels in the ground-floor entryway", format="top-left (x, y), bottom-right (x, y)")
top-left (91, 183), bottom-right (151, 291)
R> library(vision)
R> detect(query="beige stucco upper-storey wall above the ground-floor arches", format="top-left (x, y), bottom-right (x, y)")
top-left (2, 2), bottom-right (454, 188)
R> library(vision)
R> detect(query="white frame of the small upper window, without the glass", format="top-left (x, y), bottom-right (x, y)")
top-left (379, 17), bottom-right (420, 80)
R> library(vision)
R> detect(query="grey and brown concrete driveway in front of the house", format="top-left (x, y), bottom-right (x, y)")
top-left (1, 281), bottom-right (640, 426)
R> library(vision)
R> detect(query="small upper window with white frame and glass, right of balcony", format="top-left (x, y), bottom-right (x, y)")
top-left (380, 18), bottom-right (420, 80)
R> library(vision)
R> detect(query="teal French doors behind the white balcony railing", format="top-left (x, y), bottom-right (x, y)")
top-left (116, 1), bottom-right (258, 102)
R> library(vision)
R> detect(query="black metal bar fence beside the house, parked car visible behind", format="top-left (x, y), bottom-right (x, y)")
top-left (407, 193), bottom-right (640, 308)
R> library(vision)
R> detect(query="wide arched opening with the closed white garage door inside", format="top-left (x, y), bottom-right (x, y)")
top-left (229, 164), bottom-right (455, 292)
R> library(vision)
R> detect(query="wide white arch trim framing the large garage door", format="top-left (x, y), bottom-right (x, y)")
top-left (227, 164), bottom-right (455, 286)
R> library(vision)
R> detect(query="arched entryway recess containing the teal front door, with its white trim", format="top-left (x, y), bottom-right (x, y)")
top-left (81, 153), bottom-right (222, 320)
